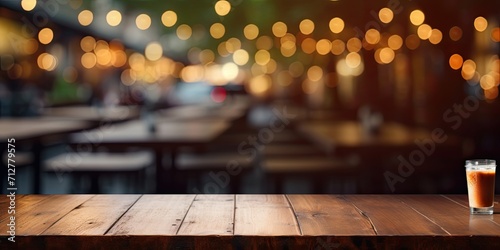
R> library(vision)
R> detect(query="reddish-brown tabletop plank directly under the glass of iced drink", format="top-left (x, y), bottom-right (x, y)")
top-left (400, 195), bottom-right (500, 235)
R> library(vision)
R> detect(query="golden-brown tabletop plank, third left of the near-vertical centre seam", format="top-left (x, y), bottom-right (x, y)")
top-left (42, 195), bottom-right (140, 235)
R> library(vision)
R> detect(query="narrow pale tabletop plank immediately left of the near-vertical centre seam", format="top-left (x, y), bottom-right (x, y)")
top-left (178, 195), bottom-right (235, 235)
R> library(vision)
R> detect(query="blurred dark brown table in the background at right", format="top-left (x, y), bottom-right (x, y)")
top-left (297, 121), bottom-right (462, 193)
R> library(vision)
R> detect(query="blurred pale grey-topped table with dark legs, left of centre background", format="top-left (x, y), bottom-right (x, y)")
top-left (71, 118), bottom-right (230, 192)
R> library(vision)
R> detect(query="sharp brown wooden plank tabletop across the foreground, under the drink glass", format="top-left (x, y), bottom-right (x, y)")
top-left (0, 194), bottom-right (500, 249)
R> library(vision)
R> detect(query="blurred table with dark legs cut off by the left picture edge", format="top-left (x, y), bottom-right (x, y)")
top-left (0, 117), bottom-right (92, 194)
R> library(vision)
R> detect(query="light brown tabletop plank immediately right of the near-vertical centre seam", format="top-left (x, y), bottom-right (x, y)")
top-left (234, 195), bottom-right (300, 236)
